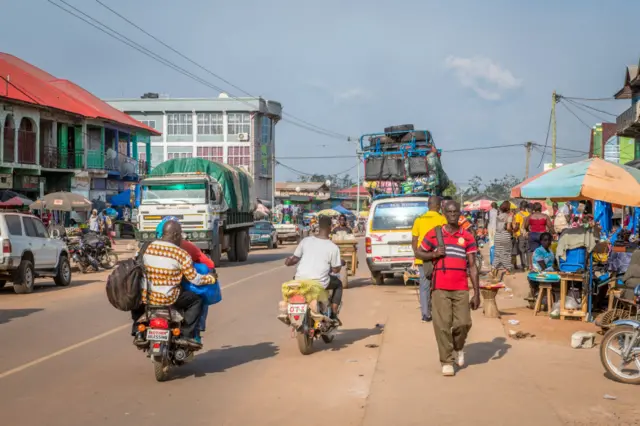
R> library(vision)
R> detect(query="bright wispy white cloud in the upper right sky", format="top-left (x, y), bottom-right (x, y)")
top-left (445, 56), bottom-right (522, 101)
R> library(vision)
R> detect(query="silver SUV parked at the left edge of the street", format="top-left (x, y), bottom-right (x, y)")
top-left (0, 212), bottom-right (71, 294)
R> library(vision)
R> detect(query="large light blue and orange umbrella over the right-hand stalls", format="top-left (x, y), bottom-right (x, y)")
top-left (511, 158), bottom-right (640, 207)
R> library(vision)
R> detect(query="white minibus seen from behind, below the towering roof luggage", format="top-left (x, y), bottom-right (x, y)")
top-left (365, 196), bottom-right (429, 285)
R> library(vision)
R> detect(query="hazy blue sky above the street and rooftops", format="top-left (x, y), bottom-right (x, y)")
top-left (0, 0), bottom-right (640, 187)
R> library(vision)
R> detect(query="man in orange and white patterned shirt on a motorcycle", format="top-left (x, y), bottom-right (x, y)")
top-left (142, 220), bottom-right (216, 346)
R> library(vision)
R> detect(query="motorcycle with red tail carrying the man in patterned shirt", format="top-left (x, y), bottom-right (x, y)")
top-left (134, 306), bottom-right (200, 382)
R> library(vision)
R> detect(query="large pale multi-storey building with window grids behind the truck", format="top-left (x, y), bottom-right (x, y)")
top-left (107, 93), bottom-right (282, 203)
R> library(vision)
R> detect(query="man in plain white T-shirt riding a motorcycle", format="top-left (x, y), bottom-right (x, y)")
top-left (284, 216), bottom-right (342, 323)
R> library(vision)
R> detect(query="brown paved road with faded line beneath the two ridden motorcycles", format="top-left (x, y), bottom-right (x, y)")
top-left (0, 246), bottom-right (384, 426)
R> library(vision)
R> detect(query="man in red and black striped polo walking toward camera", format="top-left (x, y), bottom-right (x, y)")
top-left (416, 201), bottom-right (480, 376)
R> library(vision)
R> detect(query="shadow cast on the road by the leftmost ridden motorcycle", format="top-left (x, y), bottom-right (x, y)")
top-left (174, 342), bottom-right (280, 379)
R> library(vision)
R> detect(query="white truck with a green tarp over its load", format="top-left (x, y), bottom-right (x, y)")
top-left (136, 158), bottom-right (257, 266)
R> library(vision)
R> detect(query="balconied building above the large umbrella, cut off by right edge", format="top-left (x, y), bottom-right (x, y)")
top-left (612, 65), bottom-right (640, 163)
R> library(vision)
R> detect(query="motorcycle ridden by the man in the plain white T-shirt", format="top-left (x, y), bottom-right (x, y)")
top-left (278, 282), bottom-right (340, 355)
